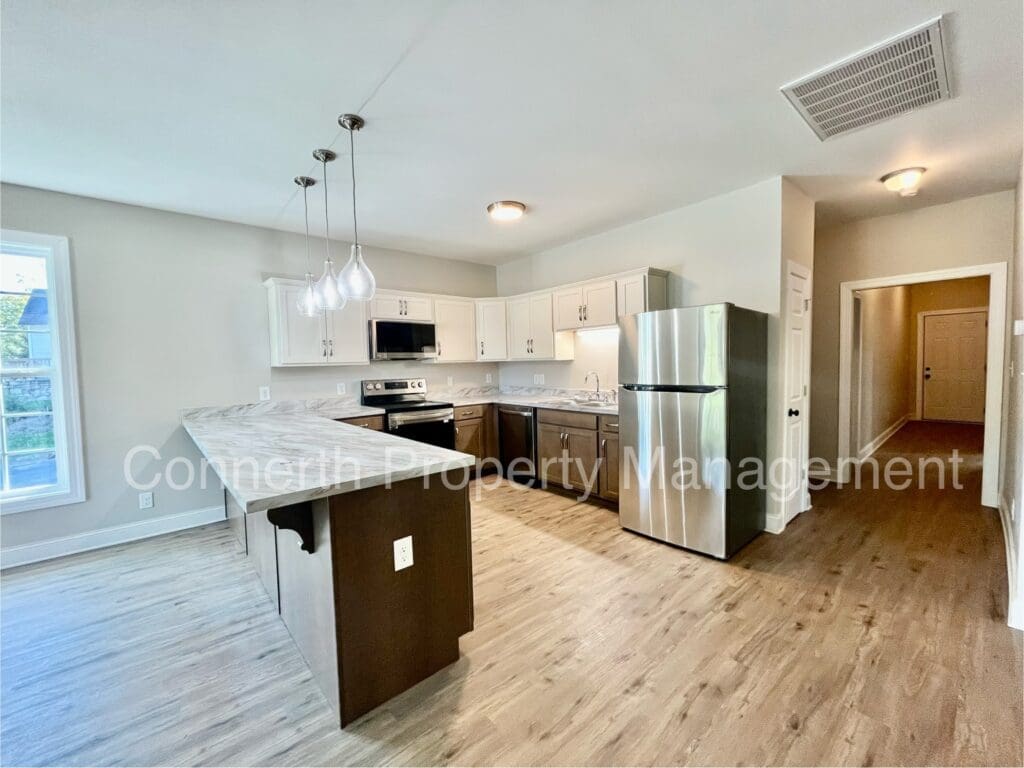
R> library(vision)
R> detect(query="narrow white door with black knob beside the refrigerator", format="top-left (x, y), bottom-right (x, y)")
top-left (782, 261), bottom-right (811, 522)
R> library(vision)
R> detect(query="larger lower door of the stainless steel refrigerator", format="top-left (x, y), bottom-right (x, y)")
top-left (618, 389), bottom-right (730, 557)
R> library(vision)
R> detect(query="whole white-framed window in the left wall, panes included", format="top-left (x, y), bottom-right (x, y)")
top-left (0, 229), bottom-right (85, 514)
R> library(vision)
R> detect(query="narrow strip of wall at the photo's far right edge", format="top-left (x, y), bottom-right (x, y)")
top-left (1000, 163), bottom-right (1024, 630)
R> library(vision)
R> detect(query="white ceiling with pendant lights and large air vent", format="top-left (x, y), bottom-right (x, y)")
top-left (0, 0), bottom-right (1022, 263)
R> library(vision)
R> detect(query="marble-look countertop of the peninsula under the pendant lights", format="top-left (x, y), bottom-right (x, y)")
top-left (181, 409), bottom-right (476, 512)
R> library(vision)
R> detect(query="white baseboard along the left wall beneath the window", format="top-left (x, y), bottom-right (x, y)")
top-left (0, 505), bottom-right (225, 569)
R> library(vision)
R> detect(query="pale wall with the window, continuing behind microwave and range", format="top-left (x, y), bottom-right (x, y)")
top-left (0, 184), bottom-right (497, 548)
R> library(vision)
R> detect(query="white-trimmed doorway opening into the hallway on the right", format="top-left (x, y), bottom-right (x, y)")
top-left (837, 264), bottom-right (1007, 507)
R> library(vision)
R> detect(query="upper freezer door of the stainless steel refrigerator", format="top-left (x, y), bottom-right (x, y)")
top-left (618, 304), bottom-right (729, 386)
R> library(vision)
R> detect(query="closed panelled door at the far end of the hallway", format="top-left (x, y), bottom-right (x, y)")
top-left (922, 311), bottom-right (988, 424)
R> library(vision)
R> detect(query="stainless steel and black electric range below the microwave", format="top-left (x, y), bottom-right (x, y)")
top-left (361, 379), bottom-right (455, 449)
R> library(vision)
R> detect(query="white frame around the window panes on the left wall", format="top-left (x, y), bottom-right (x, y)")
top-left (0, 229), bottom-right (86, 515)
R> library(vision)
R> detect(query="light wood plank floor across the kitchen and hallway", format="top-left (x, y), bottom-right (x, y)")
top-left (0, 424), bottom-right (1022, 765)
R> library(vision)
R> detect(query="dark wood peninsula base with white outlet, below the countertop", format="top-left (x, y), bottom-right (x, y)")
top-left (246, 475), bottom-right (473, 726)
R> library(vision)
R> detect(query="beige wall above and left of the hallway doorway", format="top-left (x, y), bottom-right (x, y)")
top-left (811, 190), bottom-right (1014, 462)
